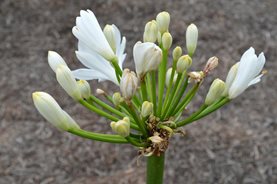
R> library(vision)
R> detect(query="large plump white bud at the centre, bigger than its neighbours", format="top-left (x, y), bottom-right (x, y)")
top-left (133, 42), bottom-right (162, 78)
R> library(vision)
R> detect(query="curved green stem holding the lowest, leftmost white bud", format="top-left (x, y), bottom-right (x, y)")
top-left (68, 129), bottom-right (128, 144)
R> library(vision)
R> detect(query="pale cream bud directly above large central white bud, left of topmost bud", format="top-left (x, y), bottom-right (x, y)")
top-left (143, 20), bottom-right (158, 43)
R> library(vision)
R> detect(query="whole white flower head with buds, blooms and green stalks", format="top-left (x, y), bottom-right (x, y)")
top-left (33, 10), bottom-right (265, 155)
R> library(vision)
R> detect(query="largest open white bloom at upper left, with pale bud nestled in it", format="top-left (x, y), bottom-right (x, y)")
top-left (72, 10), bottom-right (126, 85)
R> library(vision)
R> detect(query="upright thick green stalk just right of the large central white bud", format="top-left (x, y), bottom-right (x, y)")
top-left (157, 50), bottom-right (168, 117)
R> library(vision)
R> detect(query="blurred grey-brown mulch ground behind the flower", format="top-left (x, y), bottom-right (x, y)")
top-left (0, 0), bottom-right (277, 184)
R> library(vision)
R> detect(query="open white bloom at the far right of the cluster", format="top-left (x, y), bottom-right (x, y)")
top-left (226, 47), bottom-right (265, 99)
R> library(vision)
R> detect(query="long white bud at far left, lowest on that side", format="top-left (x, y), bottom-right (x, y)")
top-left (32, 92), bottom-right (80, 131)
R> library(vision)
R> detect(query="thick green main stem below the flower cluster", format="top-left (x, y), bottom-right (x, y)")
top-left (147, 153), bottom-right (165, 184)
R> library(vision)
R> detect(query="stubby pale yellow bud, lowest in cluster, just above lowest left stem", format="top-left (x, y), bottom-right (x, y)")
top-left (111, 117), bottom-right (130, 137)
